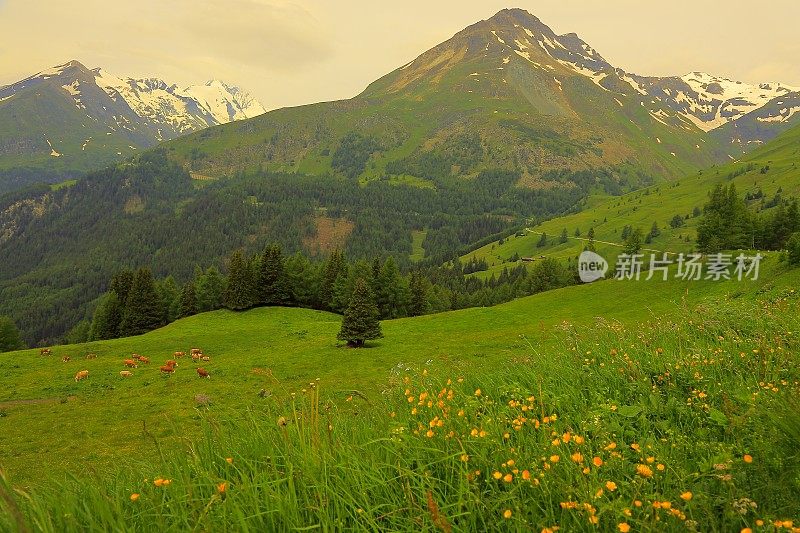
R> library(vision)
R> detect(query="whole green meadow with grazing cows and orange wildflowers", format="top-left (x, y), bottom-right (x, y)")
top-left (0, 256), bottom-right (800, 531)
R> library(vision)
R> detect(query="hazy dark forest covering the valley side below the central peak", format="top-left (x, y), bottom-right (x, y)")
top-left (0, 148), bottom-right (596, 345)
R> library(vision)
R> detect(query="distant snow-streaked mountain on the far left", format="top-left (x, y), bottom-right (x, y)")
top-left (0, 61), bottom-right (264, 192)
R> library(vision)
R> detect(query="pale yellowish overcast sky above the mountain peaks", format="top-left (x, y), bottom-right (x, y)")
top-left (0, 0), bottom-right (800, 108)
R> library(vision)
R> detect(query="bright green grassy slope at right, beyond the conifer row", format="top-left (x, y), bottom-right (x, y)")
top-left (462, 118), bottom-right (800, 276)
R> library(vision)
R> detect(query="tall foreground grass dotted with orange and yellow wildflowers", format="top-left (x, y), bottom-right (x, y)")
top-left (0, 291), bottom-right (800, 532)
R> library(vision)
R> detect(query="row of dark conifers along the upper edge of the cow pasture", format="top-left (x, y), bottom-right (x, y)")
top-left (76, 244), bottom-right (576, 342)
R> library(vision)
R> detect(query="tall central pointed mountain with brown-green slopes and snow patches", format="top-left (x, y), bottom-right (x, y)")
top-left (170, 10), bottom-right (730, 188)
